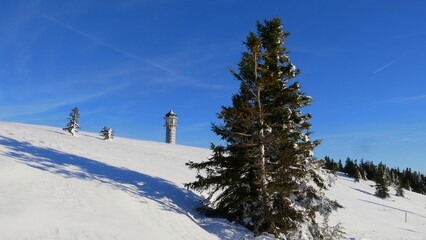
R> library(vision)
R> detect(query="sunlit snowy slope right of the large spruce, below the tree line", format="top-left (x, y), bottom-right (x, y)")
top-left (326, 173), bottom-right (426, 240)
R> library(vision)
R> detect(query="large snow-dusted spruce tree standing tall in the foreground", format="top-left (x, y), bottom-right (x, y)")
top-left (186, 17), bottom-right (339, 239)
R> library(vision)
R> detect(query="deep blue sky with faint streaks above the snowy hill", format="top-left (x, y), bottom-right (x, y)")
top-left (0, 0), bottom-right (426, 172)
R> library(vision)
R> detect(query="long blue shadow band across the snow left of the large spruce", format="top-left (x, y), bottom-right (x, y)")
top-left (0, 136), bottom-right (250, 239)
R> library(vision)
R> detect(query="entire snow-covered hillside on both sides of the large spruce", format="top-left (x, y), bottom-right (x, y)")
top-left (0, 123), bottom-right (426, 240)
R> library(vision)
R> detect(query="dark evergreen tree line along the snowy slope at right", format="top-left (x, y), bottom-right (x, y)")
top-left (324, 156), bottom-right (426, 198)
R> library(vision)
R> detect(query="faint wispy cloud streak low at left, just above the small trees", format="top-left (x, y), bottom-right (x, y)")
top-left (0, 84), bottom-right (130, 121)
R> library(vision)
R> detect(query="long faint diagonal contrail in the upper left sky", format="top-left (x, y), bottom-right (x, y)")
top-left (41, 15), bottom-right (176, 74)
